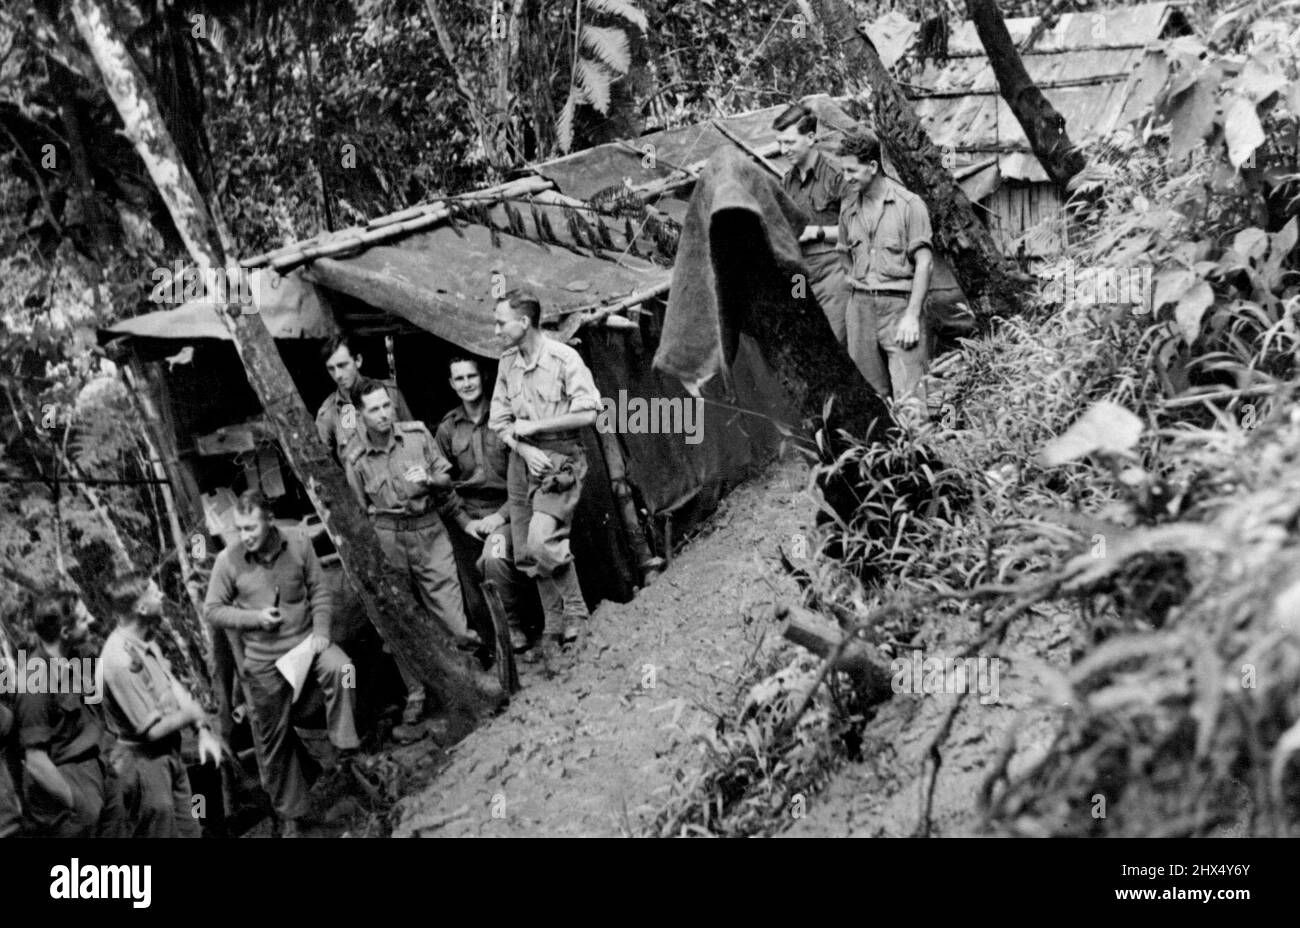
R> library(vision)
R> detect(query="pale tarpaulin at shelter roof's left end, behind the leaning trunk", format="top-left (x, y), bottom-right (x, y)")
top-left (100, 270), bottom-right (330, 341)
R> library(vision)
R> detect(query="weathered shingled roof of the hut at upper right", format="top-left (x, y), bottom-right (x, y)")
top-left (865, 3), bottom-right (1186, 186)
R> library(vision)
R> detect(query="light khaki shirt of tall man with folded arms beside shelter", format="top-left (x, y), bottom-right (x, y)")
top-left (488, 335), bottom-right (601, 435)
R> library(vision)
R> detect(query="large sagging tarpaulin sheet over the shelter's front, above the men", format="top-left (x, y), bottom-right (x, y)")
top-left (306, 225), bottom-right (672, 357)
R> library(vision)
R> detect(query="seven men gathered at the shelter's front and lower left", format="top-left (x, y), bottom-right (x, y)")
top-left (0, 285), bottom-right (601, 837)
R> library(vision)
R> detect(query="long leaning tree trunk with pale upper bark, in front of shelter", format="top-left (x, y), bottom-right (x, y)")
top-left (73, 0), bottom-right (503, 733)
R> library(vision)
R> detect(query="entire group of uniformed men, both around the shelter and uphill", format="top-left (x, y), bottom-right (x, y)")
top-left (0, 110), bottom-right (932, 836)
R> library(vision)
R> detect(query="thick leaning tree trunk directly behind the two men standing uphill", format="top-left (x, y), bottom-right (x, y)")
top-left (811, 0), bottom-right (1028, 316)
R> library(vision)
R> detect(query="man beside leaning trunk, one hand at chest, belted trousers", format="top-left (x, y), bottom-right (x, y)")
top-left (345, 381), bottom-right (482, 725)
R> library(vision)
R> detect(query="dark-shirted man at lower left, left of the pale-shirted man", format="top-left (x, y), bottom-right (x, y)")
top-left (14, 593), bottom-right (125, 838)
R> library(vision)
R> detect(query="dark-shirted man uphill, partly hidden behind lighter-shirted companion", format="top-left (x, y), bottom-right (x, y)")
top-left (772, 103), bottom-right (849, 344)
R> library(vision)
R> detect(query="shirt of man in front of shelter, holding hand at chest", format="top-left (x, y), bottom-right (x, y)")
top-left (345, 422), bottom-right (469, 525)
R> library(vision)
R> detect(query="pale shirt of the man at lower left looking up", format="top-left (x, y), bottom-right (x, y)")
top-left (99, 628), bottom-right (181, 743)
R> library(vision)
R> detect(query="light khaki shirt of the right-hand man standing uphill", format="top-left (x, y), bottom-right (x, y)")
top-left (836, 177), bottom-right (933, 294)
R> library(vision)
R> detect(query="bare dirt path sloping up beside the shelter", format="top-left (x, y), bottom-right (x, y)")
top-left (393, 460), bottom-right (814, 837)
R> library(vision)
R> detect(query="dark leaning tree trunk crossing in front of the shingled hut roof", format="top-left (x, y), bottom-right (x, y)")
top-left (966, 0), bottom-right (1086, 190)
